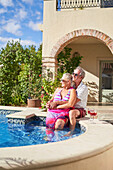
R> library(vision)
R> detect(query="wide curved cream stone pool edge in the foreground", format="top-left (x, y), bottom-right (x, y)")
top-left (0, 107), bottom-right (113, 169)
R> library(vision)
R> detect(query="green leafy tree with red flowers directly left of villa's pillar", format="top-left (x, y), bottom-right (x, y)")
top-left (19, 45), bottom-right (42, 100)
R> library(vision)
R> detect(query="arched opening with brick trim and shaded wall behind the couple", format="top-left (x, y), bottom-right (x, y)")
top-left (50, 29), bottom-right (113, 102)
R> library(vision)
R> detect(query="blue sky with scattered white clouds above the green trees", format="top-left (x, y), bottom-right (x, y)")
top-left (0, 0), bottom-right (43, 49)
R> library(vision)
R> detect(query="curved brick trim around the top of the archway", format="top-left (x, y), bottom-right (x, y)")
top-left (50, 29), bottom-right (113, 57)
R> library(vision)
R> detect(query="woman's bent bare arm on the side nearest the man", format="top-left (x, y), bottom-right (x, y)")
top-left (57, 89), bottom-right (77, 109)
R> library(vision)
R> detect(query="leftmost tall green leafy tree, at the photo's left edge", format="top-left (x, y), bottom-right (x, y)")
top-left (0, 41), bottom-right (23, 104)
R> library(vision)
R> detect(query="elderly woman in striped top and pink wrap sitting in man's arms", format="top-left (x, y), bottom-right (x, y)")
top-left (46, 73), bottom-right (76, 130)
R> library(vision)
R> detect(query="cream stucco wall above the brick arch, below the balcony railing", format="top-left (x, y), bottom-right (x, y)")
top-left (43, 0), bottom-right (113, 57)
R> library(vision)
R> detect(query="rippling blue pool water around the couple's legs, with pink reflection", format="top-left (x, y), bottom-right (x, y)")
top-left (0, 110), bottom-right (85, 148)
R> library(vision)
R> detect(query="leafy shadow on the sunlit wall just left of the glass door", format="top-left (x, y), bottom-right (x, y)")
top-left (84, 82), bottom-right (99, 102)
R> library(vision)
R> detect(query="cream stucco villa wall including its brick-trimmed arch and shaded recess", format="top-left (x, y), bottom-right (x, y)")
top-left (41, 0), bottom-right (113, 101)
